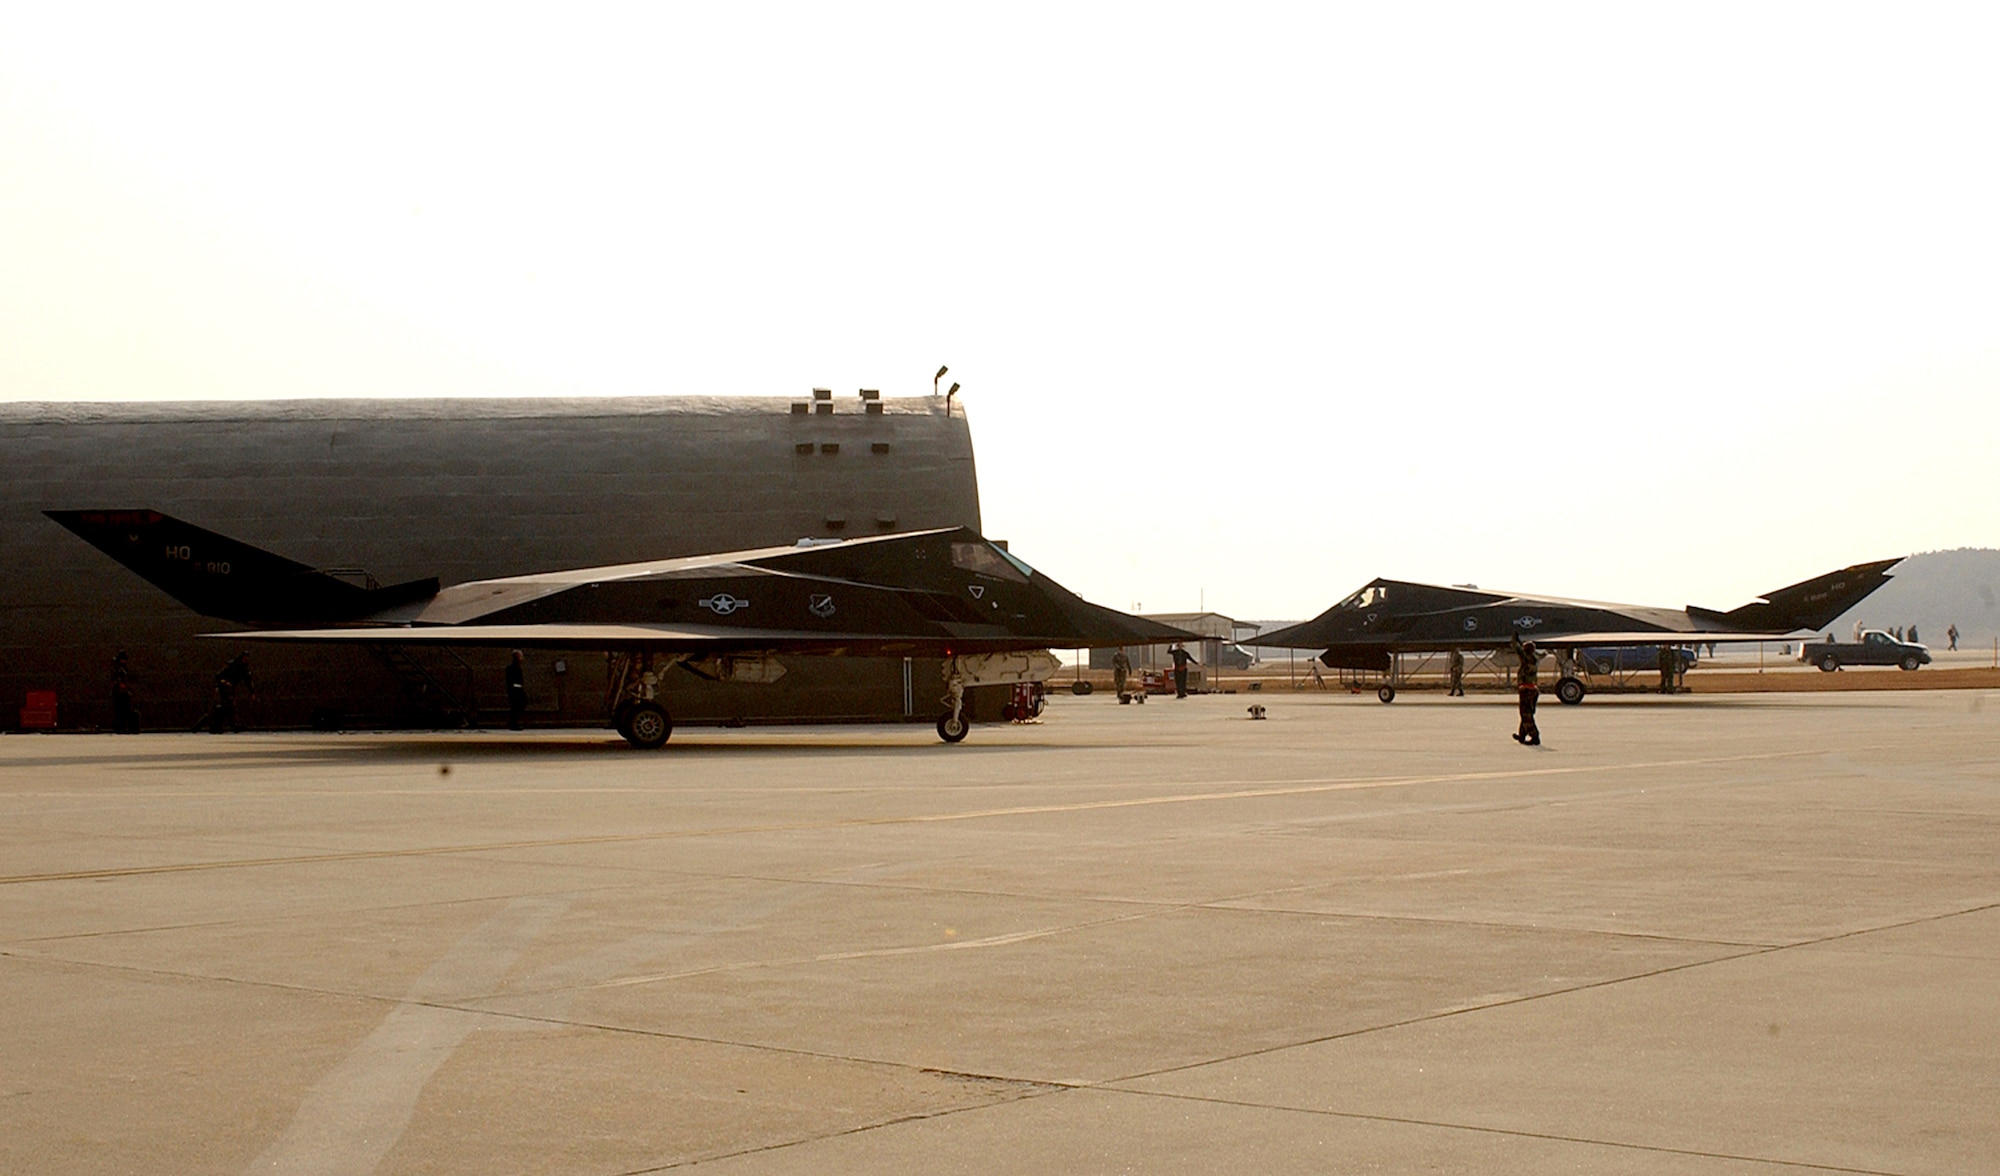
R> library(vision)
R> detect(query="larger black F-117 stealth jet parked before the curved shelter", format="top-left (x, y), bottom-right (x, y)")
top-left (44, 510), bottom-right (1198, 748)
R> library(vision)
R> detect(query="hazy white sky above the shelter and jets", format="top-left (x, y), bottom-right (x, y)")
top-left (0, 4), bottom-right (2000, 616)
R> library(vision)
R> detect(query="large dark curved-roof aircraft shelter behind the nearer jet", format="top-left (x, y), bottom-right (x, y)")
top-left (0, 390), bottom-right (980, 730)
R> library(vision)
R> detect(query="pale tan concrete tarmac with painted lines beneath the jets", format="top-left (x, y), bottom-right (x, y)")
top-left (0, 690), bottom-right (2000, 1176)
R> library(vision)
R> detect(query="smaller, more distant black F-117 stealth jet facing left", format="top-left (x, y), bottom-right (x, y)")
top-left (1250, 558), bottom-right (1902, 706)
